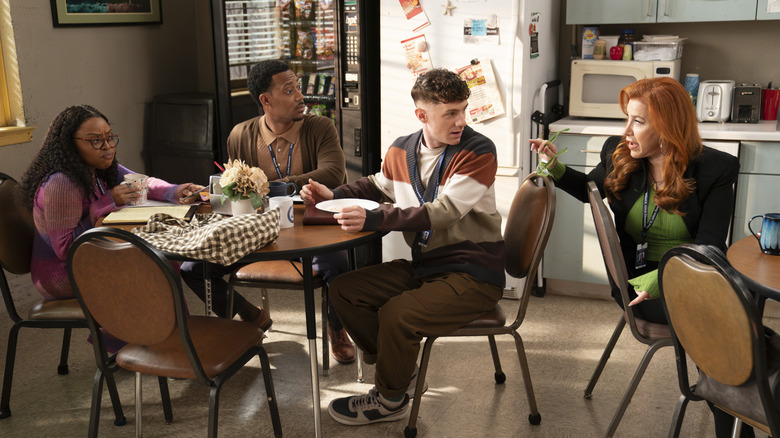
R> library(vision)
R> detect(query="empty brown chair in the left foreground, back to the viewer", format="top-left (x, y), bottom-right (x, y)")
top-left (68, 228), bottom-right (282, 437)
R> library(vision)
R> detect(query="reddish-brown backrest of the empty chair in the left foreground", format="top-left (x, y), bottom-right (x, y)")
top-left (70, 229), bottom-right (177, 345)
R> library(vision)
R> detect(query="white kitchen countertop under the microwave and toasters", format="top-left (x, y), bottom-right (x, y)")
top-left (550, 117), bottom-right (780, 142)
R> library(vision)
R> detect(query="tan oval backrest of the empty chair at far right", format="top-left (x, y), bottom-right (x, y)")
top-left (662, 254), bottom-right (755, 386)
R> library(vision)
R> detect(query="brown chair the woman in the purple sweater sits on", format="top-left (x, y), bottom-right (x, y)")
top-left (0, 173), bottom-right (125, 426)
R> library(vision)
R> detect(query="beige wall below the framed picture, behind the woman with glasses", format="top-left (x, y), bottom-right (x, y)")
top-left (0, 0), bottom-right (214, 178)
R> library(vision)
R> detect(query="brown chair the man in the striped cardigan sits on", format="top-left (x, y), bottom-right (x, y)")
top-left (404, 173), bottom-right (555, 438)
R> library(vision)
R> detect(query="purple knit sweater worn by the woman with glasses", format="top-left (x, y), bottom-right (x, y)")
top-left (30, 166), bottom-right (179, 300)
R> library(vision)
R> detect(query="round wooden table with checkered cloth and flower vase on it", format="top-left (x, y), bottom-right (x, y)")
top-left (98, 204), bottom-right (386, 437)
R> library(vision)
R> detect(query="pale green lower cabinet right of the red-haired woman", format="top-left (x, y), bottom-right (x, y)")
top-left (732, 141), bottom-right (780, 241)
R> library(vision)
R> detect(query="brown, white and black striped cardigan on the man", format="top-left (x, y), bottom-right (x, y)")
top-left (334, 126), bottom-right (506, 287)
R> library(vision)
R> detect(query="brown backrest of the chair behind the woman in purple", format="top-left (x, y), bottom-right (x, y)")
top-left (0, 173), bottom-right (35, 275)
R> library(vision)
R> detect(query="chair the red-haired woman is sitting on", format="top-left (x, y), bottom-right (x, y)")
top-left (585, 181), bottom-right (672, 437)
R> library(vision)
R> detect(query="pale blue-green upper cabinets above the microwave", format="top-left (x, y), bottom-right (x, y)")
top-left (566, 0), bottom-right (768, 24)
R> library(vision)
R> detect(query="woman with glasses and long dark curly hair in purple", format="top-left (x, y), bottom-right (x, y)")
top-left (22, 105), bottom-right (202, 300)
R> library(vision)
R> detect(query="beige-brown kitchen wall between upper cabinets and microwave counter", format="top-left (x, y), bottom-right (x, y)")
top-left (558, 0), bottom-right (780, 109)
